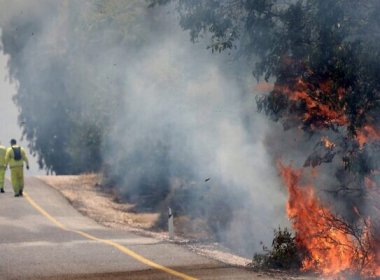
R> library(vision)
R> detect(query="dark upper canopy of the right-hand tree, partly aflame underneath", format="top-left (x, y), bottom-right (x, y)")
top-left (151, 0), bottom-right (380, 160)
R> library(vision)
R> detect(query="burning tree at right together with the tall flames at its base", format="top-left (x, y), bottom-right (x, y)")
top-left (152, 0), bottom-right (380, 277)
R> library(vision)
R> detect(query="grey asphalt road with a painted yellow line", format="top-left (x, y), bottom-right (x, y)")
top-left (0, 178), bottom-right (273, 280)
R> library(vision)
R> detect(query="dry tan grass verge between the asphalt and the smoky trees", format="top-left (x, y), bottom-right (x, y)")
top-left (37, 174), bottom-right (254, 266)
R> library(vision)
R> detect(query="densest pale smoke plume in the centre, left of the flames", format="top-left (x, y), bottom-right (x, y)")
top-left (107, 7), bottom-right (286, 255)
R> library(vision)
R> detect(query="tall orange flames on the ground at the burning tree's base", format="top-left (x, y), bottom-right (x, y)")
top-left (279, 163), bottom-right (380, 277)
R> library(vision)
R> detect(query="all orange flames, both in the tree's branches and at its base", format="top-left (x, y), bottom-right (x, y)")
top-left (272, 78), bottom-right (380, 278)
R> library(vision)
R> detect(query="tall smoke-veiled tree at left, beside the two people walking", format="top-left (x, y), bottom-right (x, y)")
top-left (1, 0), bottom-right (145, 174)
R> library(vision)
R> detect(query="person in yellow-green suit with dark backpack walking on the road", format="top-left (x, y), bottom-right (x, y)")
top-left (5, 139), bottom-right (29, 197)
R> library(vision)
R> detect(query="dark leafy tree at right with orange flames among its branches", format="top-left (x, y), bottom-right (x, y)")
top-left (151, 0), bottom-right (380, 274)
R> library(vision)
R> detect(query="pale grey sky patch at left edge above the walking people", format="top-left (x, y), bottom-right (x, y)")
top-left (0, 49), bottom-right (44, 176)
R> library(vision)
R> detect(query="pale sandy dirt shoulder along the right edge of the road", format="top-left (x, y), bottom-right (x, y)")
top-left (36, 174), bottom-right (310, 279)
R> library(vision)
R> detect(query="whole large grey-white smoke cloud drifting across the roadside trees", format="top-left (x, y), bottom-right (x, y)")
top-left (0, 1), bottom-right (286, 257)
